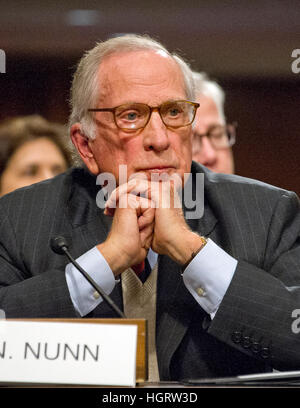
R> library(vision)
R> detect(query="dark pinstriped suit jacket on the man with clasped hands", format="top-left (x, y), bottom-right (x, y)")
top-left (0, 163), bottom-right (300, 380)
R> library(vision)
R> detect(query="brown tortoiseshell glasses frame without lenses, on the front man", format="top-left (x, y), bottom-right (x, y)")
top-left (88, 100), bottom-right (200, 131)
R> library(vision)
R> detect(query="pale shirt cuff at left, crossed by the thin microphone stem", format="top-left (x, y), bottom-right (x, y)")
top-left (65, 247), bottom-right (116, 316)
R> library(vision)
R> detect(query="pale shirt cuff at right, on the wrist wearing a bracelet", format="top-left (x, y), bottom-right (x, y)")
top-left (182, 239), bottom-right (237, 319)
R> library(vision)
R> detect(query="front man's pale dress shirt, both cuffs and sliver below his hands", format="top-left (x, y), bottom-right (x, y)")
top-left (65, 239), bottom-right (237, 319)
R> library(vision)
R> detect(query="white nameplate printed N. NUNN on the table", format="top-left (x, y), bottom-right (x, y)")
top-left (0, 320), bottom-right (137, 386)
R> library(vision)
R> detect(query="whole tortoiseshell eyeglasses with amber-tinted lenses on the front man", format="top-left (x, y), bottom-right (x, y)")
top-left (88, 101), bottom-right (200, 131)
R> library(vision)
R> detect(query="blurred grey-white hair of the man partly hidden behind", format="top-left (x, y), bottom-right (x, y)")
top-left (193, 72), bottom-right (226, 124)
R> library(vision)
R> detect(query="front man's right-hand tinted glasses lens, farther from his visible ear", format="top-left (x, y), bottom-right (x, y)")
top-left (160, 101), bottom-right (195, 128)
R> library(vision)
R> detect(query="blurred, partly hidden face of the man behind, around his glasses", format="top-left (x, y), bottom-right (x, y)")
top-left (193, 95), bottom-right (234, 174)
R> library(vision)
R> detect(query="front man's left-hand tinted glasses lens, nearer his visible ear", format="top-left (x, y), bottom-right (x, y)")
top-left (115, 103), bottom-right (150, 130)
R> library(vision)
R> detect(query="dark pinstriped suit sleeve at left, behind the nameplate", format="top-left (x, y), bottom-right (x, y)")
top-left (0, 204), bottom-right (76, 318)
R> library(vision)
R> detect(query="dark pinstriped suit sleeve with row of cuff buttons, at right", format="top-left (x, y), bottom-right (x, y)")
top-left (208, 192), bottom-right (300, 370)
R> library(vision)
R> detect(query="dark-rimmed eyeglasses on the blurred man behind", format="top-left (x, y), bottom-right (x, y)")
top-left (193, 122), bottom-right (237, 152)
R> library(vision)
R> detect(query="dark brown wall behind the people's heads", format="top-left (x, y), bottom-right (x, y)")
top-left (0, 0), bottom-right (300, 194)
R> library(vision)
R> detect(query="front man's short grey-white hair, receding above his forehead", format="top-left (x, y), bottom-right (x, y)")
top-left (69, 34), bottom-right (194, 139)
